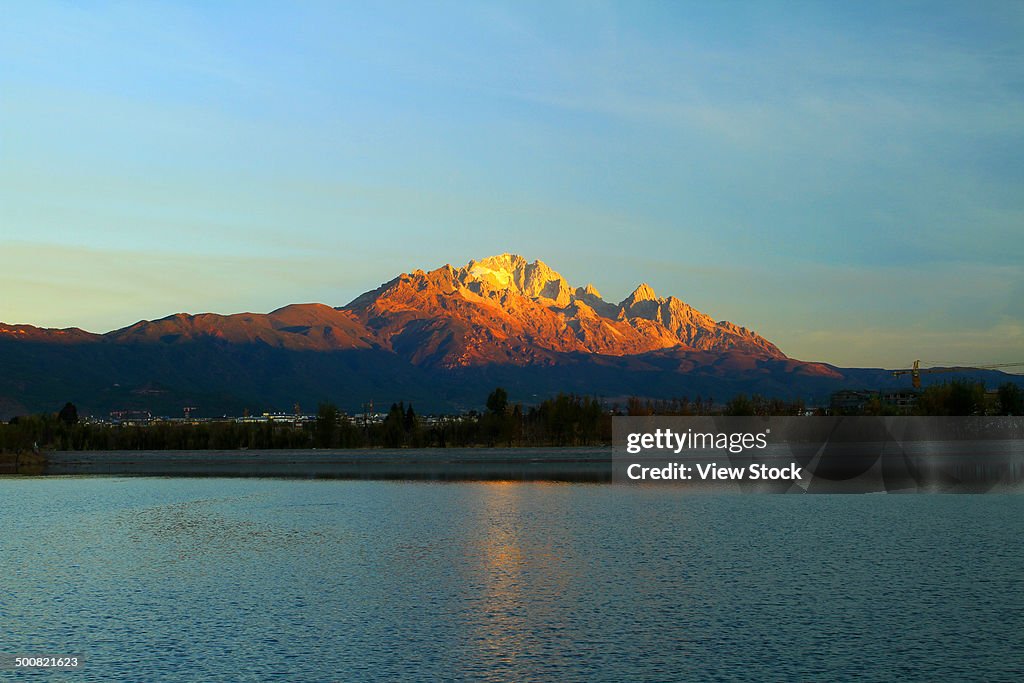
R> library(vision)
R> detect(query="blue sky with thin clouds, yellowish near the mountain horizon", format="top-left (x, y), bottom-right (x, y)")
top-left (0, 0), bottom-right (1024, 368)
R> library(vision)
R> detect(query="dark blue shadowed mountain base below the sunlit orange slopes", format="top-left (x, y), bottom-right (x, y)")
top-left (0, 339), bottom-right (1008, 419)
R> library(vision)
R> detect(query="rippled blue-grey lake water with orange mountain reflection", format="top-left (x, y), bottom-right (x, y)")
top-left (0, 477), bottom-right (1024, 681)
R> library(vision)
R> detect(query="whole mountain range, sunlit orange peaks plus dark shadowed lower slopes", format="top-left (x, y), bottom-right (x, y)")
top-left (0, 254), bottom-right (1011, 418)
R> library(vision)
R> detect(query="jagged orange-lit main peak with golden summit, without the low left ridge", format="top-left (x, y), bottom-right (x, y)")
top-left (341, 253), bottom-right (785, 367)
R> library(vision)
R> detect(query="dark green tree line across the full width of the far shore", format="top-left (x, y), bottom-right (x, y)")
top-left (0, 381), bottom-right (1024, 453)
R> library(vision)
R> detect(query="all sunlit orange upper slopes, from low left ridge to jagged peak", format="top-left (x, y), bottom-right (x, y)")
top-left (9, 254), bottom-right (786, 368)
